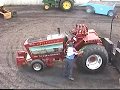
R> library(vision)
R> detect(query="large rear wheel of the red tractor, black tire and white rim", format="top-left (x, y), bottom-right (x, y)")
top-left (76, 44), bottom-right (108, 73)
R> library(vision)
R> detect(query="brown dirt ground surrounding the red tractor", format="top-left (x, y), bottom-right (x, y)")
top-left (0, 6), bottom-right (120, 89)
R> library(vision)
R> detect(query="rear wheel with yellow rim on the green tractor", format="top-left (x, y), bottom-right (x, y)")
top-left (60, 0), bottom-right (74, 11)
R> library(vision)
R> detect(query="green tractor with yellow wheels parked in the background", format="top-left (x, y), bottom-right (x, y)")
top-left (42, 0), bottom-right (74, 11)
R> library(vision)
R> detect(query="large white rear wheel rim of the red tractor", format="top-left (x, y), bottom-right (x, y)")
top-left (86, 54), bottom-right (102, 70)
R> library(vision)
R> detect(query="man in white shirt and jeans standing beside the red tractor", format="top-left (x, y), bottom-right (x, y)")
top-left (64, 42), bottom-right (83, 80)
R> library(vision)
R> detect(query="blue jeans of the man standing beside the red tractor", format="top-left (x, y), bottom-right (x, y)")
top-left (64, 58), bottom-right (75, 77)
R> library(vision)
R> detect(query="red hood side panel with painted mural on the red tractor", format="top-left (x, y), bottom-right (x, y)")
top-left (24, 38), bottom-right (64, 60)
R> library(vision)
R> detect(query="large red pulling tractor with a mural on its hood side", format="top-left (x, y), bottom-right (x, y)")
top-left (16, 24), bottom-right (108, 72)
